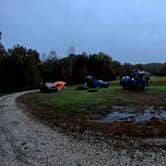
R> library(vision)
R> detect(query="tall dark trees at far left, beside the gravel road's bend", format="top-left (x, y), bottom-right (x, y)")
top-left (0, 45), bottom-right (41, 92)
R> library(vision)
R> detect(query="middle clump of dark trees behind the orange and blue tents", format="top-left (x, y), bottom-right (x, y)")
top-left (40, 52), bottom-right (117, 84)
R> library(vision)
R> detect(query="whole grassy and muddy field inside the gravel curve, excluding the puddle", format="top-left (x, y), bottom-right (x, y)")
top-left (19, 77), bottom-right (166, 137)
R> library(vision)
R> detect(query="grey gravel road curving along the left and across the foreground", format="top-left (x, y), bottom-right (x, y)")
top-left (0, 93), bottom-right (166, 166)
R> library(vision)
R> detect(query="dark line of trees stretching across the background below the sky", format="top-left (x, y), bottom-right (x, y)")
top-left (0, 45), bottom-right (166, 93)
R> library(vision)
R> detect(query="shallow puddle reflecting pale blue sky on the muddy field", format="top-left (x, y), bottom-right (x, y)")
top-left (98, 109), bottom-right (166, 123)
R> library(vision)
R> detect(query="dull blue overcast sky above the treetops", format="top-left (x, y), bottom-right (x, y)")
top-left (0, 0), bottom-right (166, 63)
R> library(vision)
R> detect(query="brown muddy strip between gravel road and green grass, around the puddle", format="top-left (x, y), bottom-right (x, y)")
top-left (17, 92), bottom-right (166, 140)
